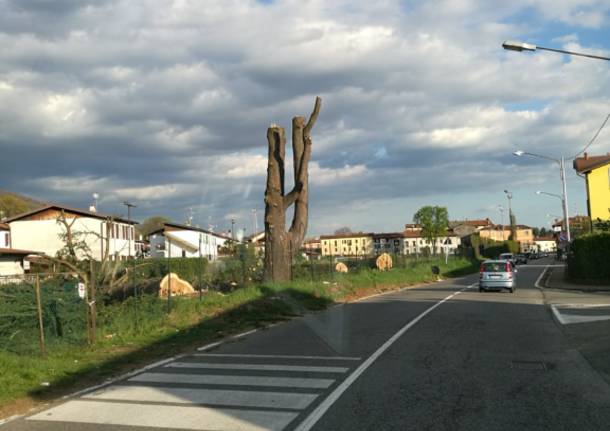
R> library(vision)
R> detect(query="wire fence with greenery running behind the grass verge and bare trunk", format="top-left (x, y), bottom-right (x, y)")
top-left (0, 246), bottom-right (470, 356)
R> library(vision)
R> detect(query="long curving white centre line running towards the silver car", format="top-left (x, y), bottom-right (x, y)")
top-left (295, 283), bottom-right (478, 431)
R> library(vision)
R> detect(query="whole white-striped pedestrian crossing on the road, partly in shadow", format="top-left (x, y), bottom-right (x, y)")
top-left (28, 353), bottom-right (360, 431)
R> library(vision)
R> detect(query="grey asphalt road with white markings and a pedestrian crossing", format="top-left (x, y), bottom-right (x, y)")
top-left (0, 261), bottom-right (610, 431)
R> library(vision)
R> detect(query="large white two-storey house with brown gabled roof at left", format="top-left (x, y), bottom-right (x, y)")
top-left (4, 204), bottom-right (136, 260)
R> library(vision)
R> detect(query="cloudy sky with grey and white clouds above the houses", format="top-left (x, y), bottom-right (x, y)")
top-left (0, 0), bottom-right (610, 234)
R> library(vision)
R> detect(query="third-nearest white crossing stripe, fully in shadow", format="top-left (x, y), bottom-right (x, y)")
top-left (129, 373), bottom-right (334, 389)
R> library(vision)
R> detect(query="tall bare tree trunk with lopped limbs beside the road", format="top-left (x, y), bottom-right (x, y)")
top-left (265, 97), bottom-right (322, 281)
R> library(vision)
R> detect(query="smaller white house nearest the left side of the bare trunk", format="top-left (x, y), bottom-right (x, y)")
top-left (148, 223), bottom-right (230, 261)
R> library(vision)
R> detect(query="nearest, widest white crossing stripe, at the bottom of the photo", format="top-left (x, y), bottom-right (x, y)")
top-left (28, 400), bottom-right (297, 431)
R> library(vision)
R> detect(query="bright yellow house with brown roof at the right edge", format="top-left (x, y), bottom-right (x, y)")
top-left (573, 153), bottom-right (610, 221)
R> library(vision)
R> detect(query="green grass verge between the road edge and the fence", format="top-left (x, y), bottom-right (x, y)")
top-left (0, 258), bottom-right (478, 417)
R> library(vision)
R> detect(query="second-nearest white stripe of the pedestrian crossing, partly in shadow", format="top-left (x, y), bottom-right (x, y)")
top-left (84, 385), bottom-right (318, 410)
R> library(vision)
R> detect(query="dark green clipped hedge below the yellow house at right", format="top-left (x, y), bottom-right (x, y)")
top-left (567, 233), bottom-right (610, 284)
